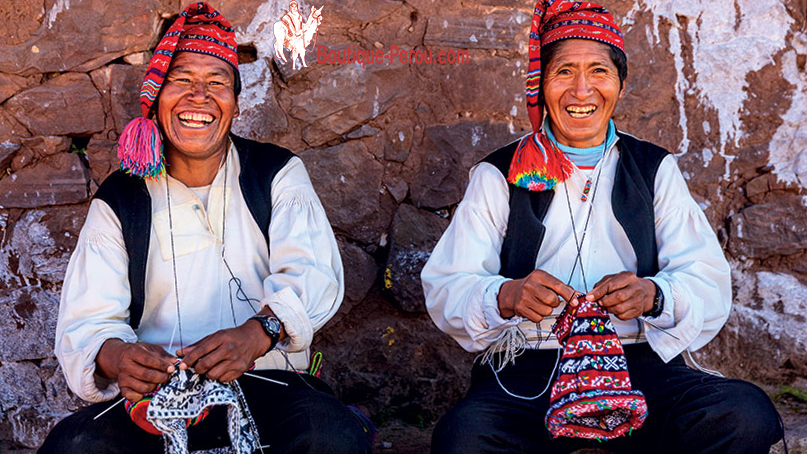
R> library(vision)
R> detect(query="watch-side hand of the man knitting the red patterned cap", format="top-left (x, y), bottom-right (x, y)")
top-left (586, 271), bottom-right (656, 320)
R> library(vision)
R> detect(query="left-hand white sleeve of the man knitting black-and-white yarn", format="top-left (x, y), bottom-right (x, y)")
top-left (55, 200), bottom-right (137, 402)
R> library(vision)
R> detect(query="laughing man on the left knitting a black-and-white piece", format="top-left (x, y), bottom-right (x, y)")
top-left (40, 3), bottom-right (371, 453)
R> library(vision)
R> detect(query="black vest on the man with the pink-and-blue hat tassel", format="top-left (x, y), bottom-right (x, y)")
top-left (93, 135), bottom-right (294, 329)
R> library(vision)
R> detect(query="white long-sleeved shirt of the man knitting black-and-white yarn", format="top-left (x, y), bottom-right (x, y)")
top-left (56, 146), bottom-right (344, 402)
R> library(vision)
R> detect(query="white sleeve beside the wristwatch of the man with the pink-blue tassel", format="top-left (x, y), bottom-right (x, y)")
top-left (262, 157), bottom-right (345, 352)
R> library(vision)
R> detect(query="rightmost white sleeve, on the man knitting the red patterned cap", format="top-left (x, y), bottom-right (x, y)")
top-left (646, 155), bottom-right (732, 361)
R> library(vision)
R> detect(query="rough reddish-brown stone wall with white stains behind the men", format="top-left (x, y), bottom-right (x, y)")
top-left (0, 0), bottom-right (807, 449)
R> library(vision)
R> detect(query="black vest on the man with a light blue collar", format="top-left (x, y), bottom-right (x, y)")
top-left (482, 132), bottom-right (669, 279)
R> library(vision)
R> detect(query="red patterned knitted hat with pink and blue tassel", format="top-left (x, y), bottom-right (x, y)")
top-left (118, 2), bottom-right (240, 178)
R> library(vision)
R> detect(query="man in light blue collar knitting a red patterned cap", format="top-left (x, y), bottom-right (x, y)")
top-left (422, 0), bottom-right (782, 454)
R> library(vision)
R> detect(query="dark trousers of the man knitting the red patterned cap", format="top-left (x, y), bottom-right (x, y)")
top-left (431, 344), bottom-right (783, 454)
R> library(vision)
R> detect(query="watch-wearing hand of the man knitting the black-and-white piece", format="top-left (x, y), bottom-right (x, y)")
top-left (177, 308), bottom-right (286, 383)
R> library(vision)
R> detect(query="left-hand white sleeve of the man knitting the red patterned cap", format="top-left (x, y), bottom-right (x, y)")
top-left (421, 163), bottom-right (521, 352)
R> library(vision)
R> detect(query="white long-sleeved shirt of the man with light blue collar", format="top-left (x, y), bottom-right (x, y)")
top-left (421, 134), bottom-right (731, 361)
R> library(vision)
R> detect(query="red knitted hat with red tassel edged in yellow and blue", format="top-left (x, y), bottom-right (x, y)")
top-left (507, 0), bottom-right (625, 191)
